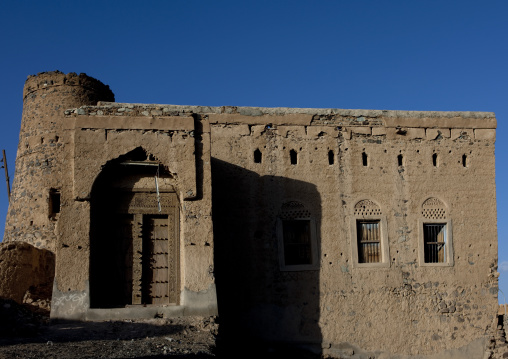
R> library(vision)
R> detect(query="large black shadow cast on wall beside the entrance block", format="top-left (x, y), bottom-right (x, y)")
top-left (212, 158), bottom-right (322, 352)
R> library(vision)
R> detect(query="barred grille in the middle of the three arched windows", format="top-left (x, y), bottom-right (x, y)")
top-left (356, 220), bottom-right (381, 263)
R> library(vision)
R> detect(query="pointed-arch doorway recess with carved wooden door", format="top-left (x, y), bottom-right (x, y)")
top-left (90, 148), bottom-right (180, 308)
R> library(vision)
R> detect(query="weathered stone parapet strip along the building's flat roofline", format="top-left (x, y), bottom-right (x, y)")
top-left (65, 102), bottom-right (497, 140)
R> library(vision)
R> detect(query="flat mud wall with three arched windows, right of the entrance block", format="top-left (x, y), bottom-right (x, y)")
top-left (201, 108), bottom-right (498, 355)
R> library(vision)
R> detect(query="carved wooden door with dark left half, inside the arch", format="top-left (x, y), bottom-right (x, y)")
top-left (92, 190), bottom-right (180, 308)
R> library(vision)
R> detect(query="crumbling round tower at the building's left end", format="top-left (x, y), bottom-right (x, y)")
top-left (4, 71), bottom-right (114, 251)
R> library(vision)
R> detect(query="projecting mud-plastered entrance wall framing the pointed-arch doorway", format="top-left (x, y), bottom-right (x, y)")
top-left (52, 104), bottom-right (217, 319)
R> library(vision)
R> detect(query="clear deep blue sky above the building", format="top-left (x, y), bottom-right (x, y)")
top-left (0, 0), bottom-right (508, 301)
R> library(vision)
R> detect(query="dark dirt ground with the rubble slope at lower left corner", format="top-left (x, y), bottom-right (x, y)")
top-left (0, 301), bottom-right (218, 359)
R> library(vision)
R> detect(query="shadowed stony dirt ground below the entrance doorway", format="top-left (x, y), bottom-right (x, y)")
top-left (0, 319), bottom-right (215, 359)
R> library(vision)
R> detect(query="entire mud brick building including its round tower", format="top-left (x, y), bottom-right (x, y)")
top-left (4, 72), bottom-right (498, 357)
